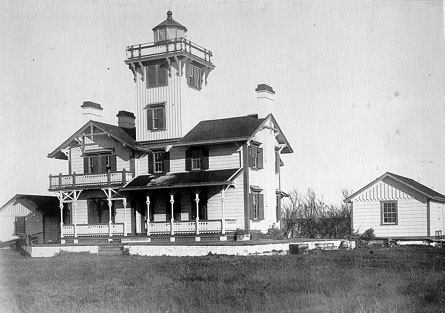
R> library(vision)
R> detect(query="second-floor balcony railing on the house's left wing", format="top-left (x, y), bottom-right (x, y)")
top-left (49, 169), bottom-right (133, 190)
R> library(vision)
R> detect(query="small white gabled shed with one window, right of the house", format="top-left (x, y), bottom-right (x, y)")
top-left (345, 172), bottom-right (445, 238)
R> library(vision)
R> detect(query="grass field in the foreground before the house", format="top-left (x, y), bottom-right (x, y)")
top-left (0, 247), bottom-right (445, 313)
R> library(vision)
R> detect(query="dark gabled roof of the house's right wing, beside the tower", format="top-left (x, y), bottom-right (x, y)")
top-left (175, 114), bottom-right (292, 153)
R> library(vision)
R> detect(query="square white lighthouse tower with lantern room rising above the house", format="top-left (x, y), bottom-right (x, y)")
top-left (125, 11), bottom-right (215, 141)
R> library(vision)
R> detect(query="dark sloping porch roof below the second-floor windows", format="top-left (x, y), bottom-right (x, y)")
top-left (121, 168), bottom-right (242, 191)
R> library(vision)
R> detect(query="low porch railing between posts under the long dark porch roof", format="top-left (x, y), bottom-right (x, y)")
top-left (148, 219), bottom-right (237, 234)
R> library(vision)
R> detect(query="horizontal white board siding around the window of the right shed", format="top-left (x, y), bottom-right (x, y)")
top-left (353, 199), bottom-right (427, 237)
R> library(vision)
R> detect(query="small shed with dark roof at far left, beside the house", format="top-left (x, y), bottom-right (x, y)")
top-left (0, 194), bottom-right (60, 243)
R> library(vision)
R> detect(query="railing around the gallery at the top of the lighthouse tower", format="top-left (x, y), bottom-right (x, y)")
top-left (126, 38), bottom-right (213, 63)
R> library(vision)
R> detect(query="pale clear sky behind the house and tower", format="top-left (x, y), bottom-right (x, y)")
top-left (0, 0), bottom-right (445, 205)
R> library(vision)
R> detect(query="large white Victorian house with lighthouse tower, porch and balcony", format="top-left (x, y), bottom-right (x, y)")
top-left (48, 11), bottom-right (293, 243)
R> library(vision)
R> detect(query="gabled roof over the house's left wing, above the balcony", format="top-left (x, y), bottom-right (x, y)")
top-left (48, 120), bottom-right (137, 159)
